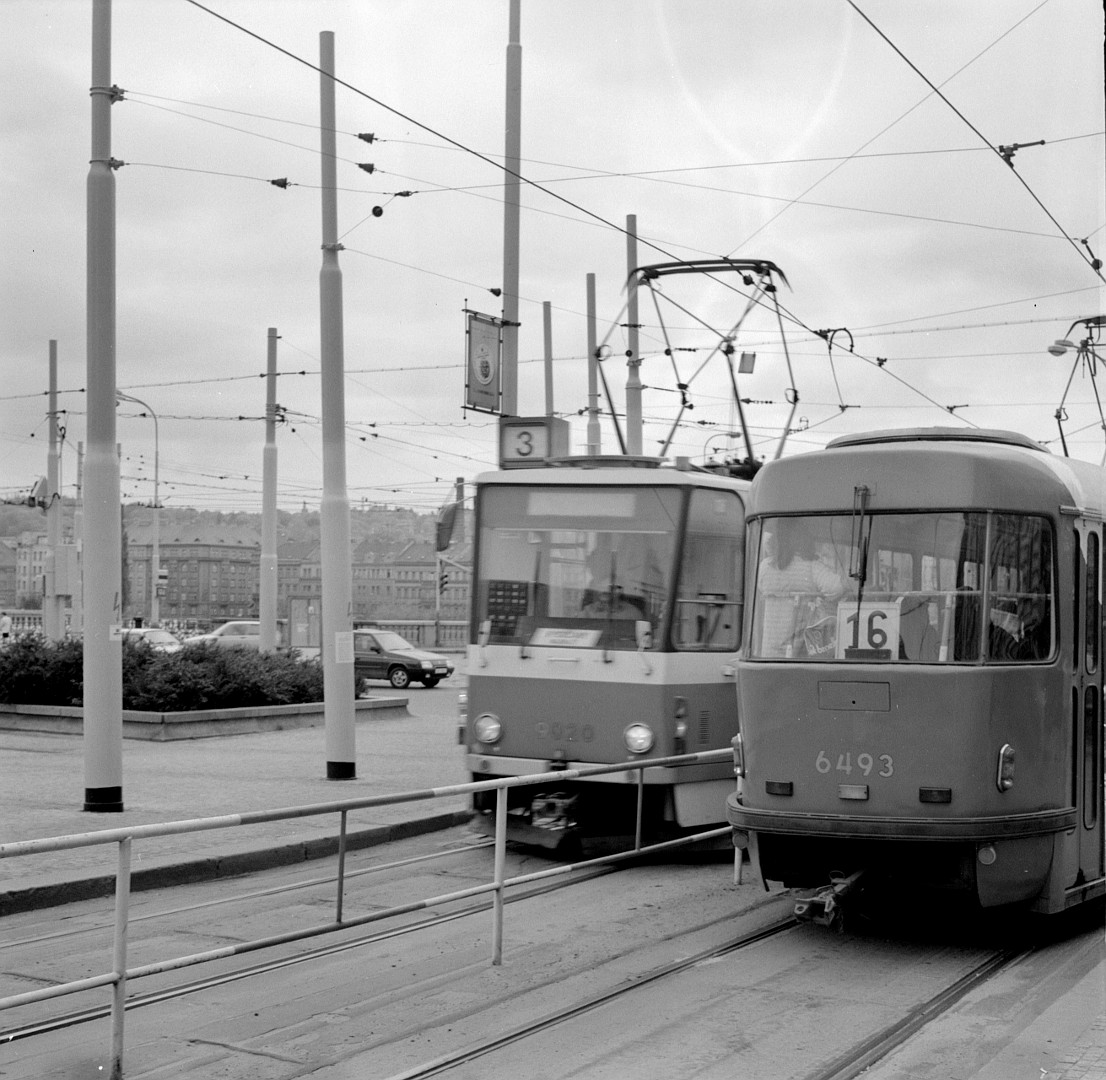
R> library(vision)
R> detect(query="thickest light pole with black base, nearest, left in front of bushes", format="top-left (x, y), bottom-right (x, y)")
top-left (83, 0), bottom-right (123, 812)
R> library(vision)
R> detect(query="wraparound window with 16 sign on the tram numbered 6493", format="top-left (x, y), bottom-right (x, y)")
top-left (749, 511), bottom-right (1055, 664)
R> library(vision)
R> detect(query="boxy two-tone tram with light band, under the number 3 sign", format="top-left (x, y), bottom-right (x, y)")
top-left (460, 456), bottom-right (749, 853)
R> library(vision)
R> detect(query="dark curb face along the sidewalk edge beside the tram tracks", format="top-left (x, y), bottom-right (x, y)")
top-left (0, 810), bottom-right (472, 917)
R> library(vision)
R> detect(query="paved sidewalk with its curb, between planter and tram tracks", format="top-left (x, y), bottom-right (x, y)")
top-left (0, 693), bottom-right (469, 915)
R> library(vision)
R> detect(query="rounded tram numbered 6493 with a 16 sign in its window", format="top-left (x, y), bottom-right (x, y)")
top-left (727, 428), bottom-right (1106, 922)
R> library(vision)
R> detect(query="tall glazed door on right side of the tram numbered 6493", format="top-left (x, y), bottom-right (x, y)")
top-left (1072, 520), bottom-right (1106, 882)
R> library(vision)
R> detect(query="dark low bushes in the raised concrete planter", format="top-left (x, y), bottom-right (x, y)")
top-left (0, 637), bottom-right (323, 713)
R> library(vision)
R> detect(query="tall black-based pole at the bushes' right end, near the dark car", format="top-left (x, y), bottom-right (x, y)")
top-left (319, 30), bottom-right (357, 780)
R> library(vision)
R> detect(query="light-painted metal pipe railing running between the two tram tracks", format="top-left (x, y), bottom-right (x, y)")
top-left (0, 749), bottom-right (732, 1080)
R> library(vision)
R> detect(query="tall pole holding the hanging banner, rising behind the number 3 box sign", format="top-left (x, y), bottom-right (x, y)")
top-left (501, 0), bottom-right (522, 416)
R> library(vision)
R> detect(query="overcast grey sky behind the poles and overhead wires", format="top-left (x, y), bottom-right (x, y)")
top-left (0, 0), bottom-right (1106, 510)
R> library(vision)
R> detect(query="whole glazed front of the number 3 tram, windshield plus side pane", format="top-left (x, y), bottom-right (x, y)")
top-left (474, 485), bottom-right (744, 651)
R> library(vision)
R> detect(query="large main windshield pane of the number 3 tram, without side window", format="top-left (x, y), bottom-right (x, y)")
top-left (476, 485), bottom-right (684, 648)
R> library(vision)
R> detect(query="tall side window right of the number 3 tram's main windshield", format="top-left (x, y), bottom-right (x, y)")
top-left (672, 489), bottom-right (744, 652)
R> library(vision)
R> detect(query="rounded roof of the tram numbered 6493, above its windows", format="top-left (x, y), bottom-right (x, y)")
top-left (750, 428), bottom-right (1106, 517)
